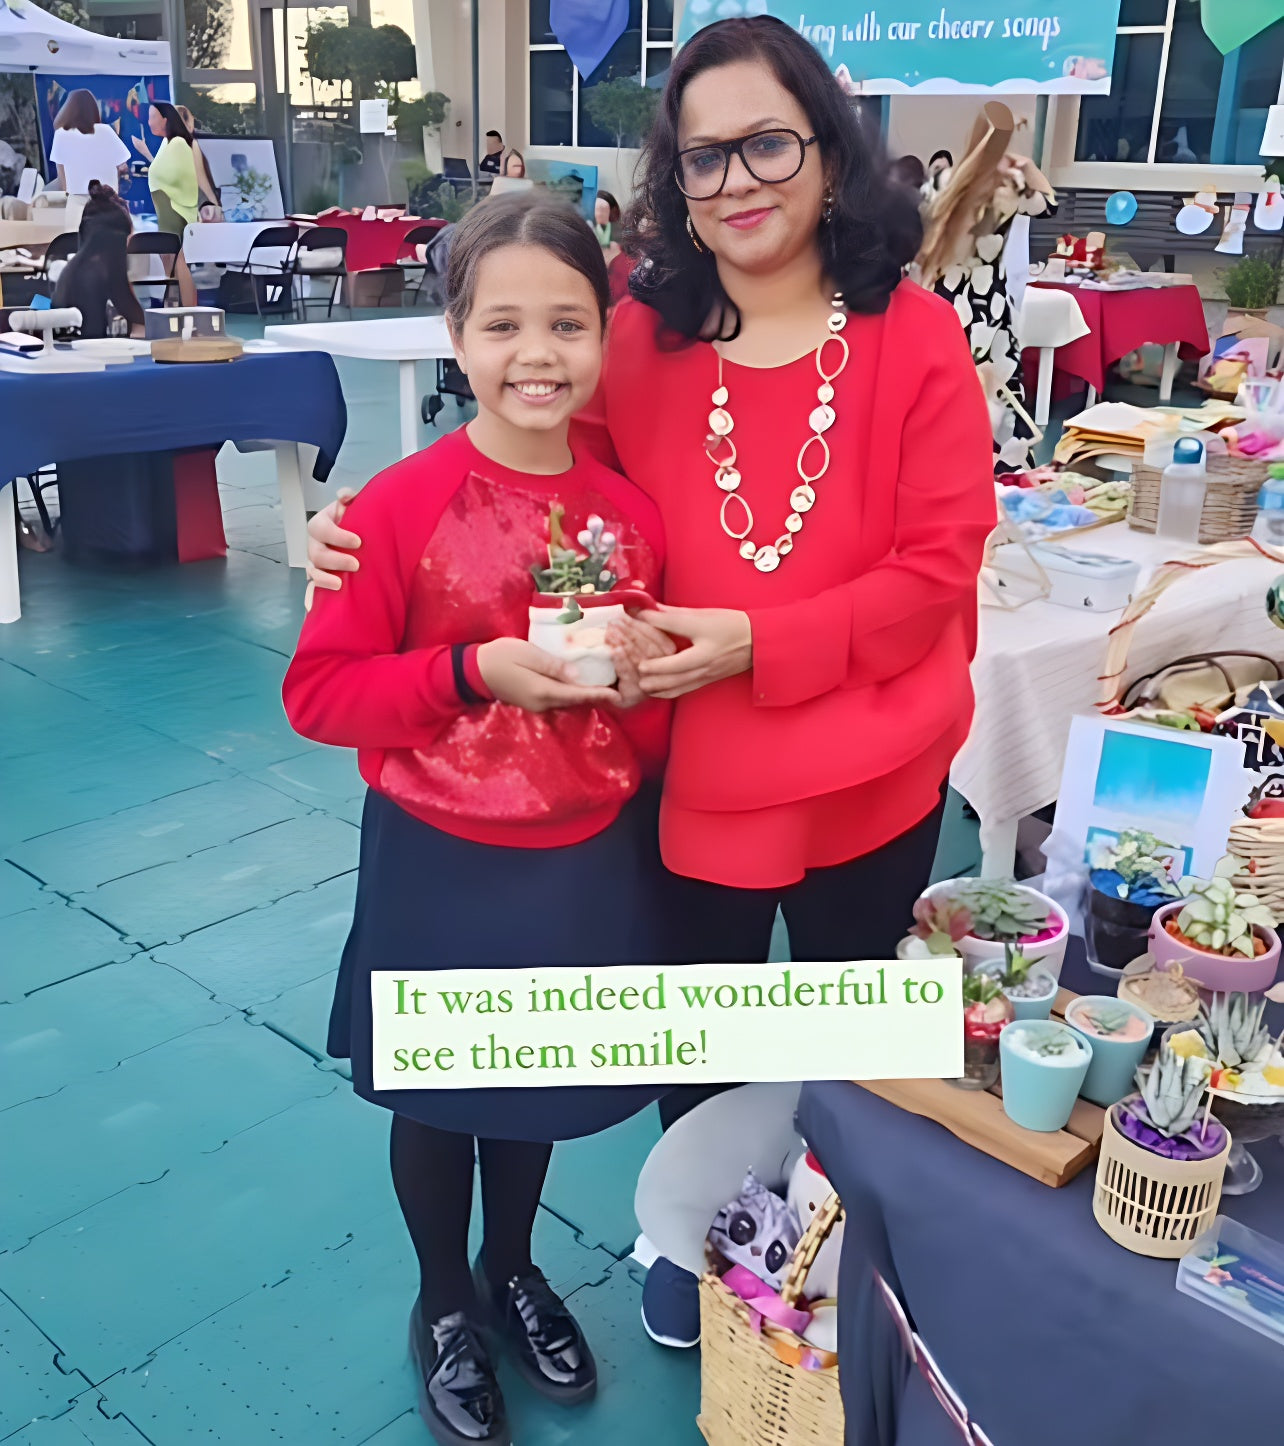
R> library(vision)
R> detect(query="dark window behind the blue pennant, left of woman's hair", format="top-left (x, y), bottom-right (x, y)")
top-left (529, 0), bottom-right (674, 147)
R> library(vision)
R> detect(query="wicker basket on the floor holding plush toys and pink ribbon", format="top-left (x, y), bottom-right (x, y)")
top-left (696, 1194), bottom-right (843, 1446)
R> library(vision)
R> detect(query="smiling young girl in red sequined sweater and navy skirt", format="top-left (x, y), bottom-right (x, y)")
top-left (283, 195), bottom-right (680, 1446)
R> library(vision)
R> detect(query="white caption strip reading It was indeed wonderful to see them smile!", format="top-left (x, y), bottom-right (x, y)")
top-left (370, 959), bottom-right (963, 1090)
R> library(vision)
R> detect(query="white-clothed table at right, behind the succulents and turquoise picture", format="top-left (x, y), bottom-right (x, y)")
top-left (950, 522), bottom-right (1284, 876)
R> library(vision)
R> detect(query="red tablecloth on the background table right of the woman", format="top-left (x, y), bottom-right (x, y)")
top-left (1027, 282), bottom-right (1209, 393)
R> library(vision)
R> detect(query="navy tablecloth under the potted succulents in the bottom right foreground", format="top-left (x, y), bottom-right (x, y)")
top-left (798, 954), bottom-right (1284, 1446)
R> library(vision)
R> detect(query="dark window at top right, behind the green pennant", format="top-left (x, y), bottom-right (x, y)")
top-left (1074, 0), bottom-right (1284, 166)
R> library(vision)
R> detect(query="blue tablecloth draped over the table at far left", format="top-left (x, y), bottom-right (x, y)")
top-left (0, 351), bottom-right (347, 486)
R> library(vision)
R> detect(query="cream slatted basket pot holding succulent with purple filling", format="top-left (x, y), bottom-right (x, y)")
top-left (1092, 1109), bottom-right (1231, 1259)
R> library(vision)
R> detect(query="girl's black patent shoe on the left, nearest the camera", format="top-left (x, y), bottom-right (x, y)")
top-left (411, 1300), bottom-right (512, 1446)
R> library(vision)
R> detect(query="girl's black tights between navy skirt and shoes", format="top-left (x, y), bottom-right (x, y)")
top-left (390, 1115), bottom-right (552, 1322)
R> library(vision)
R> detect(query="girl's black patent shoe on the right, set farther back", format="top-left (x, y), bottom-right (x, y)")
top-left (473, 1261), bottom-right (597, 1406)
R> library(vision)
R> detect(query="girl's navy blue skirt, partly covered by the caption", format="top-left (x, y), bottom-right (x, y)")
top-left (327, 787), bottom-right (690, 1141)
